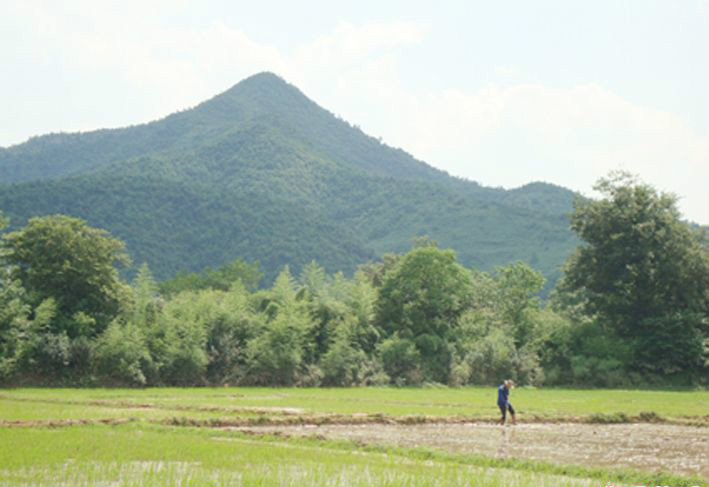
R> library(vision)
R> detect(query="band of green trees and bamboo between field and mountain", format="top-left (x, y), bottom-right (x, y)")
top-left (0, 174), bottom-right (709, 387)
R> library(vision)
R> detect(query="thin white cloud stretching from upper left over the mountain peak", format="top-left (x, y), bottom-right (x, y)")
top-left (0, 5), bottom-right (425, 139)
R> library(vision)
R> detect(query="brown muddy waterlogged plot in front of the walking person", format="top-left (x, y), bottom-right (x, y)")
top-left (240, 423), bottom-right (709, 479)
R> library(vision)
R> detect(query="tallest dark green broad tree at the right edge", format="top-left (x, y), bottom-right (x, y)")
top-left (560, 172), bottom-right (709, 376)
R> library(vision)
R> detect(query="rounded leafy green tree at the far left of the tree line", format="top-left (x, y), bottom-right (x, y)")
top-left (2, 215), bottom-right (128, 338)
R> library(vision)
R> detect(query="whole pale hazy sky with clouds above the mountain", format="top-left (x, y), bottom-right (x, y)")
top-left (0, 0), bottom-right (709, 224)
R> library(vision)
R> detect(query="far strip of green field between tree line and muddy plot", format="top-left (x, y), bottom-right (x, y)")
top-left (0, 387), bottom-right (709, 419)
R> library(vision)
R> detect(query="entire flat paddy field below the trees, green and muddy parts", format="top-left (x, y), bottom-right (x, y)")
top-left (0, 388), bottom-right (709, 487)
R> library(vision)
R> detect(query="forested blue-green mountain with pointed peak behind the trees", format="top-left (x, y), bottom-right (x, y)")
top-left (0, 73), bottom-right (577, 288)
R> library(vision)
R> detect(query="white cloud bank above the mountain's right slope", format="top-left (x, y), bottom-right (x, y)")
top-left (324, 77), bottom-right (709, 223)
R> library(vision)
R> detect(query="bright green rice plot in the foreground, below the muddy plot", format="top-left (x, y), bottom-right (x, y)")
top-left (0, 425), bottom-right (648, 487)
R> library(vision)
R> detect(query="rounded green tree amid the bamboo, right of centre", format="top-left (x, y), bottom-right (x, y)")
top-left (377, 245), bottom-right (472, 382)
